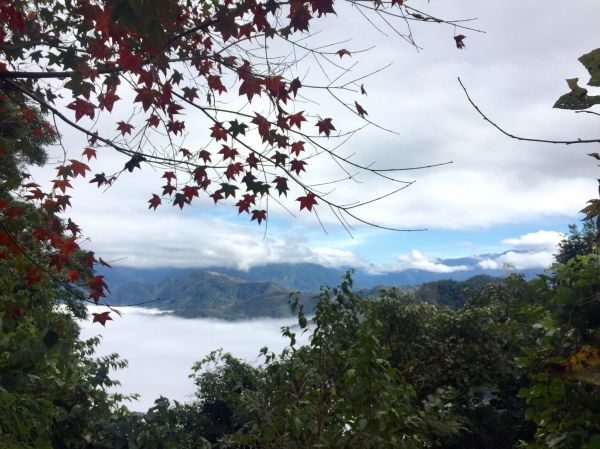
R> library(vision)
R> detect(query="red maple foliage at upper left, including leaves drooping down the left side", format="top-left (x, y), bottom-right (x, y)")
top-left (0, 0), bottom-right (472, 324)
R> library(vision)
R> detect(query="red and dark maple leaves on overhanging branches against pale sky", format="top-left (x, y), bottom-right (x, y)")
top-left (0, 0), bottom-right (464, 228)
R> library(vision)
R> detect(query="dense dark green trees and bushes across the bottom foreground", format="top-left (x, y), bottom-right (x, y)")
top-left (0, 218), bottom-right (600, 449)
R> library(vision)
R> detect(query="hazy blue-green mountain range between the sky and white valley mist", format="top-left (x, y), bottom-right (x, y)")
top-left (99, 256), bottom-right (543, 320)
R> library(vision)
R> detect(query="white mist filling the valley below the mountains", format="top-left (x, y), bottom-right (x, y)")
top-left (80, 307), bottom-right (307, 411)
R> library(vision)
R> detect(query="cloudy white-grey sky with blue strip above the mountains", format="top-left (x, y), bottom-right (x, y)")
top-left (33, 0), bottom-right (600, 272)
